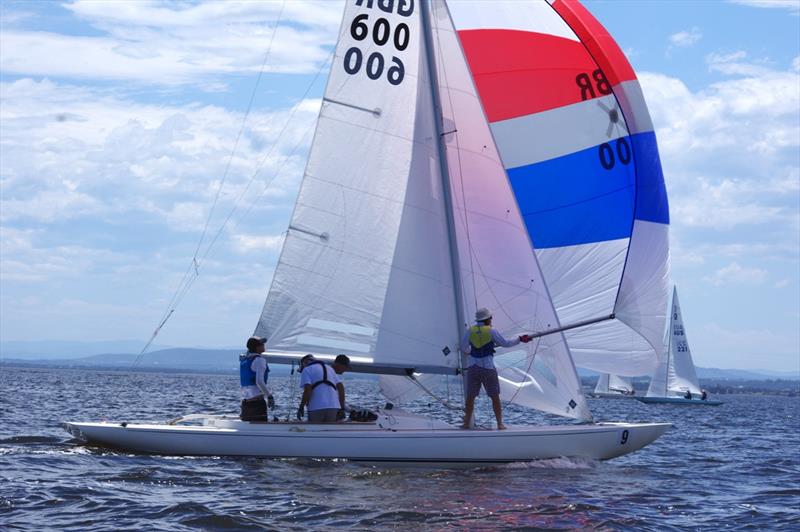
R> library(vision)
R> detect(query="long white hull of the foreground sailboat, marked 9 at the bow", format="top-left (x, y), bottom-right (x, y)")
top-left (64, 410), bottom-right (671, 465)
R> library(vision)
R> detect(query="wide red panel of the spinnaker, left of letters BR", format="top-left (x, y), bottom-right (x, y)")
top-left (458, 29), bottom-right (600, 122)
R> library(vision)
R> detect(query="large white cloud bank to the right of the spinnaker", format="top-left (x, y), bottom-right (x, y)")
top-left (639, 52), bottom-right (800, 237)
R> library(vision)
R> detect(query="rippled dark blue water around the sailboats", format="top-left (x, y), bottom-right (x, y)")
top-left (0, 366), bottom-right (800, 530)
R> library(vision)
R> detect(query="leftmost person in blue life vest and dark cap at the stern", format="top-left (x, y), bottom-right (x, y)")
top-left (239, 336), bottom-right (275, 421)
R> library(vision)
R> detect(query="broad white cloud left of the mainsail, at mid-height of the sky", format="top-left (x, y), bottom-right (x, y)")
top-left (0, 79), bottom-right (319, 224)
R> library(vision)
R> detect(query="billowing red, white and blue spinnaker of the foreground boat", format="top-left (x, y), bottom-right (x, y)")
top-left (450, 0), bottom-right (669, 375)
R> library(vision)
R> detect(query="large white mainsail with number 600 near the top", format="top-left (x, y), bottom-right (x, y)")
top-left (256, 2), bottom-right (458, 366)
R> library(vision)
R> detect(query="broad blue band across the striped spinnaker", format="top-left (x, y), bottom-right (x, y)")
top-left (508, 132), bottom-right (669, 249)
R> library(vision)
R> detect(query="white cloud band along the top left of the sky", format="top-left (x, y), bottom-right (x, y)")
top-left (0, 1), bottom-right (342, 83)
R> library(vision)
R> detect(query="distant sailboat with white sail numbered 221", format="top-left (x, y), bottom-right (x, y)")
top-left (636, 287), bottom-right (722, 406)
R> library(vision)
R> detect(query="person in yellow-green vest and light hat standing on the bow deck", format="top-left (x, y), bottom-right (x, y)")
top-left (461, 308), bottom-right (531, 430)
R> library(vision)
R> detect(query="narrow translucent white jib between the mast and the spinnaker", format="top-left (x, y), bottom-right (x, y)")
top-left (432, 1), bottom-right (591, 419)
